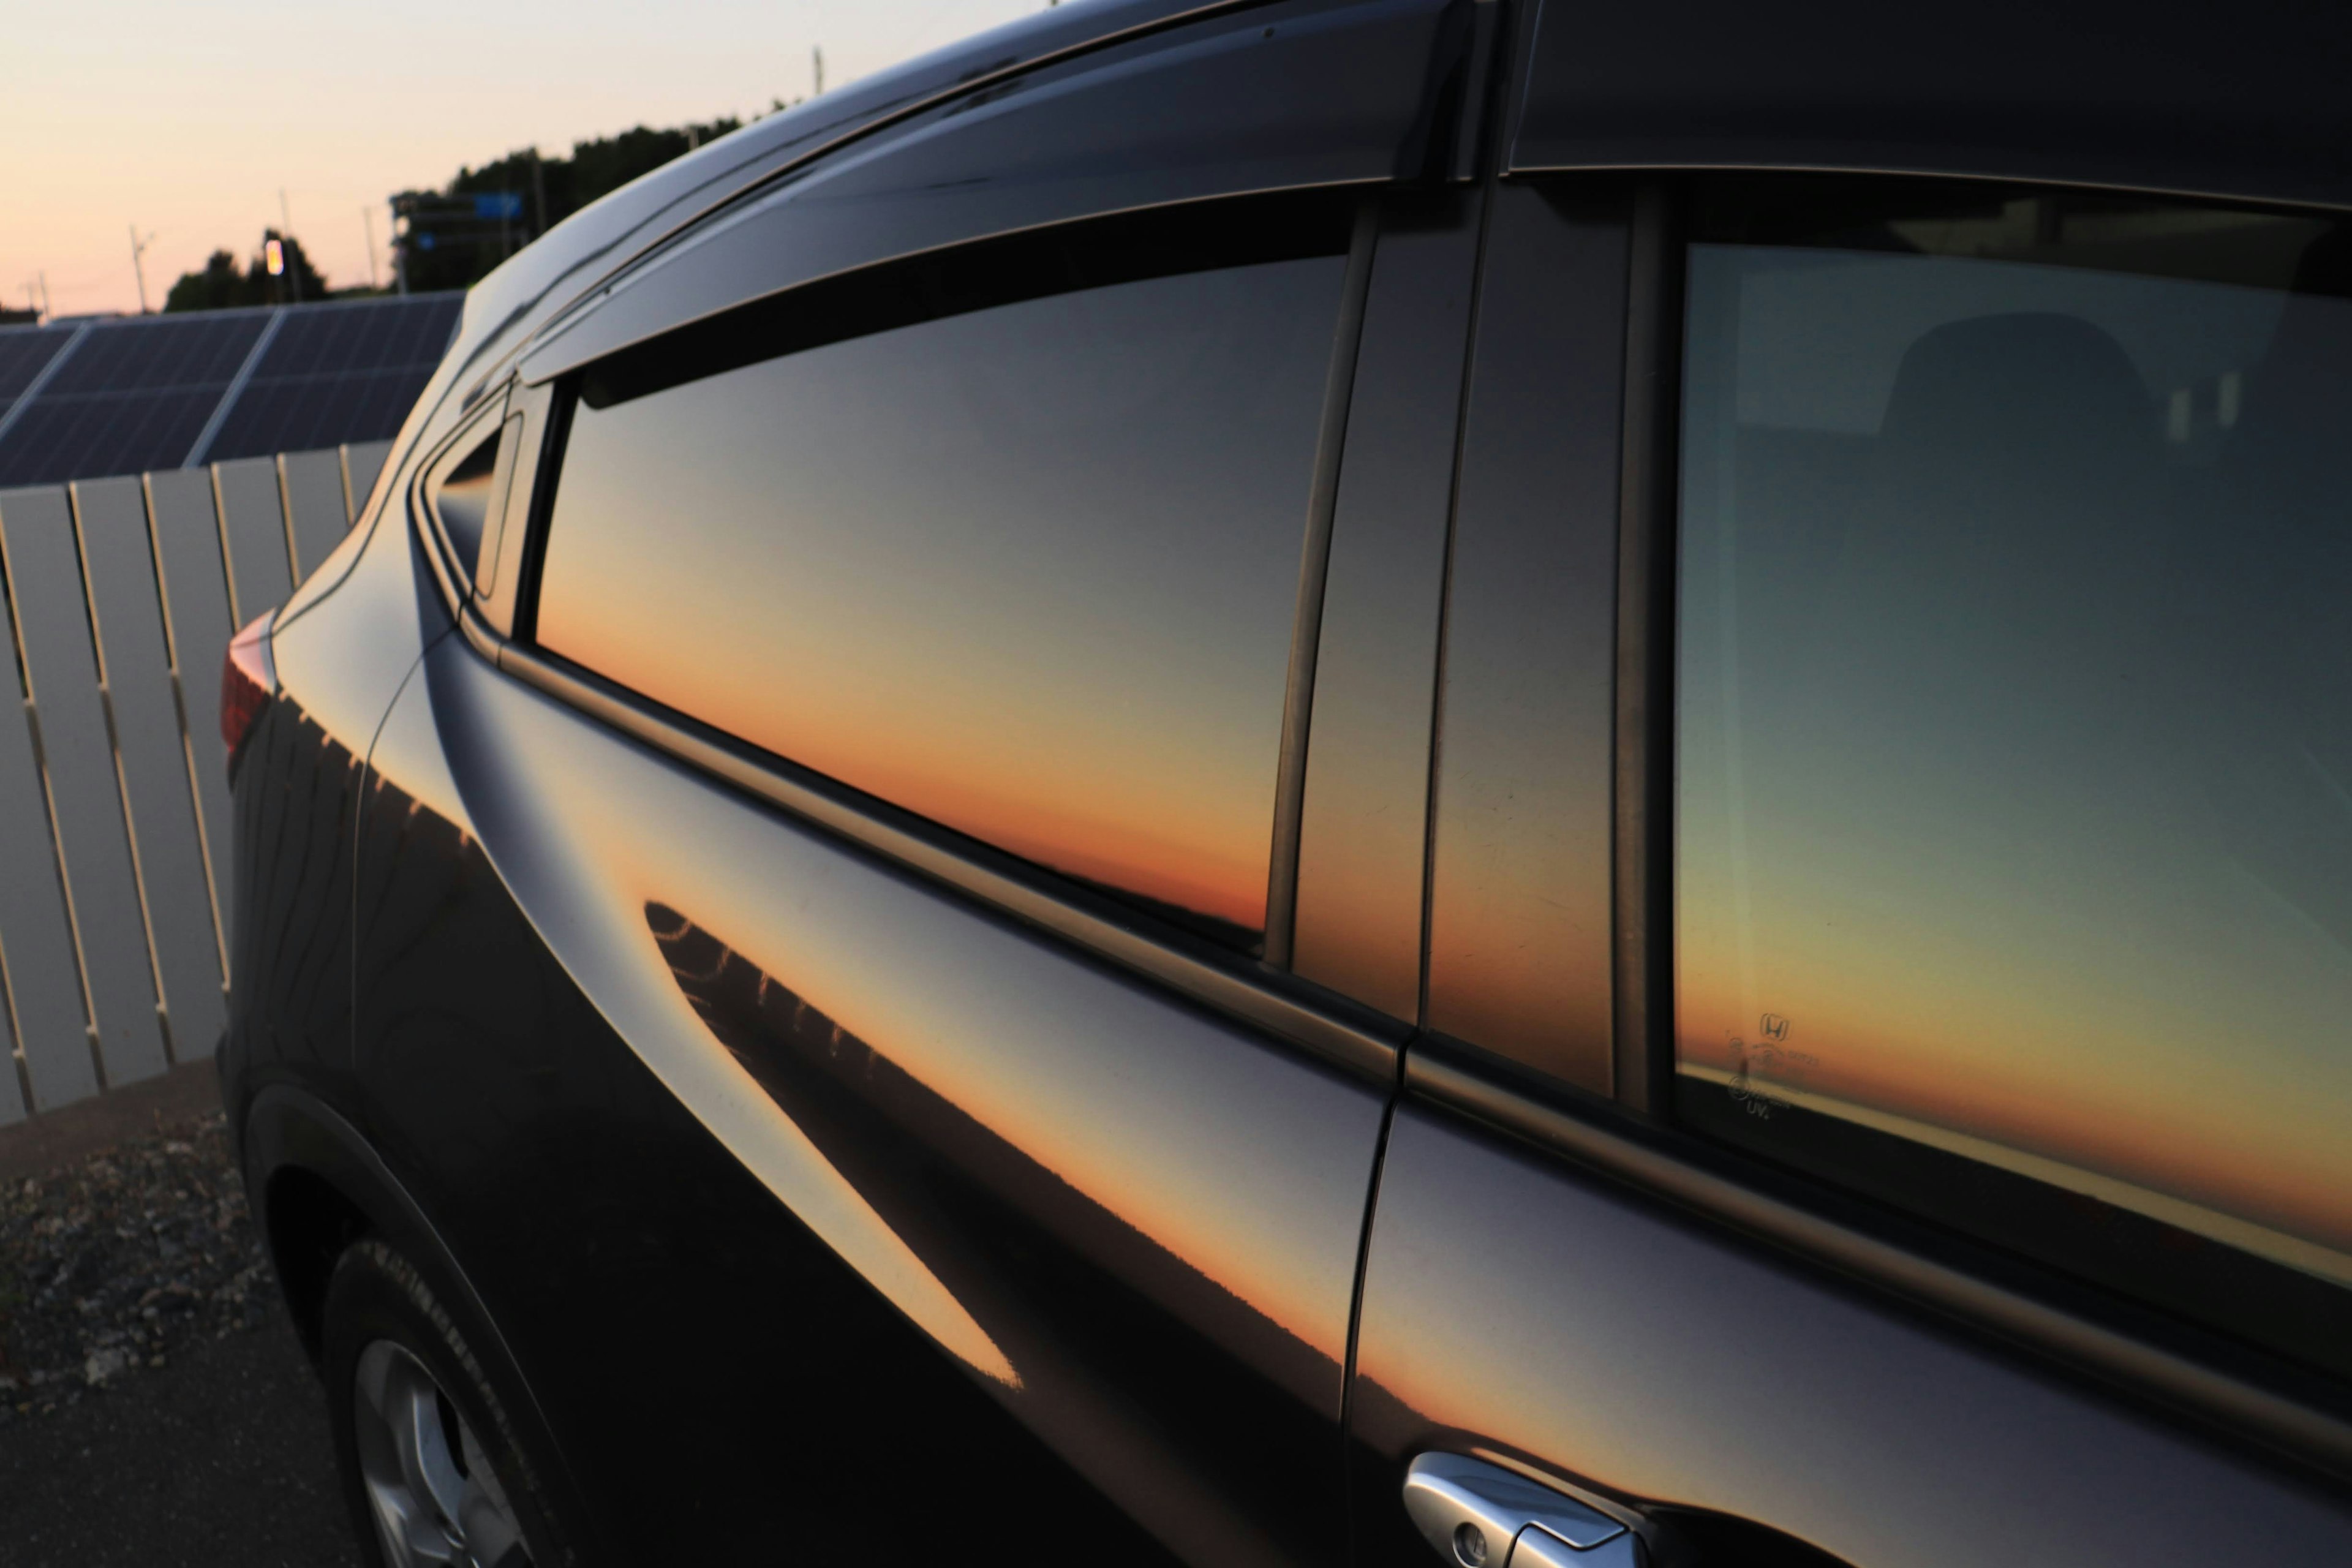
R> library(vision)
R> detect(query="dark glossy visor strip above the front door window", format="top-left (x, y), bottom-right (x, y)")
top-left (1510, 0), bottom-right (2352, 205)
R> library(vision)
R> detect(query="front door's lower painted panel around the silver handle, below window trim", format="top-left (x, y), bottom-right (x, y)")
top-left (1355, 1105), bottom-right (2352, 1568)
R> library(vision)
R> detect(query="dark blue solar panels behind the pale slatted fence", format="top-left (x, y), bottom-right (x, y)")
top-left (0, 294), bottom-right (463, 486)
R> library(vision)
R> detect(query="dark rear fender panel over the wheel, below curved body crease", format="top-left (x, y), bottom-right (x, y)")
top-left (338, 639), bottom-right (1194, 1561)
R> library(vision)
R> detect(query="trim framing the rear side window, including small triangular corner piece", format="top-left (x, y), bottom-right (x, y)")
top-left (414, 188), bottom-right (1411, 1088)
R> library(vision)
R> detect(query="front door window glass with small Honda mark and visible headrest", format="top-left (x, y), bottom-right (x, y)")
top-left (1675, 181), bottom-right (2352, 1371)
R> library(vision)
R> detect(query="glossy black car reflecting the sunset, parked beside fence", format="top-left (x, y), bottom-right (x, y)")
top-left (221, 0), bottom-right (2352, 1568)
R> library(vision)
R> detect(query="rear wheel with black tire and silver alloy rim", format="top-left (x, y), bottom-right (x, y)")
top-left (320, 1237), bottom-right (576, 1568)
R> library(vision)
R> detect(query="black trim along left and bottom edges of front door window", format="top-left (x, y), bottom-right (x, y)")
top-left (1404, 169), bottom-right (2352, 1486)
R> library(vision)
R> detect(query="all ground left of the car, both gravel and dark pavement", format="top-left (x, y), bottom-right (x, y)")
top-left (0, 1104), bottom-right (358, 1568)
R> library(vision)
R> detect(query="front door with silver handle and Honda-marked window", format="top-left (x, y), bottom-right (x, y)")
top-left (1350, 7), bottom-right (2352, 1568)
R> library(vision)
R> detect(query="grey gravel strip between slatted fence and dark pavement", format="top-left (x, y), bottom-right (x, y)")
top-left (0, 1114), bottom-right (277, 1431)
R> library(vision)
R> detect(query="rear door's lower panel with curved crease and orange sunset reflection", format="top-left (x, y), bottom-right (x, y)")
top-left (416, 620), bottom-right (1383, 1561)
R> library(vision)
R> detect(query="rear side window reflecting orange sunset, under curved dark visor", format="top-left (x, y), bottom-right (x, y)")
top-left (537, 205), bottom-right (1348, 948)
